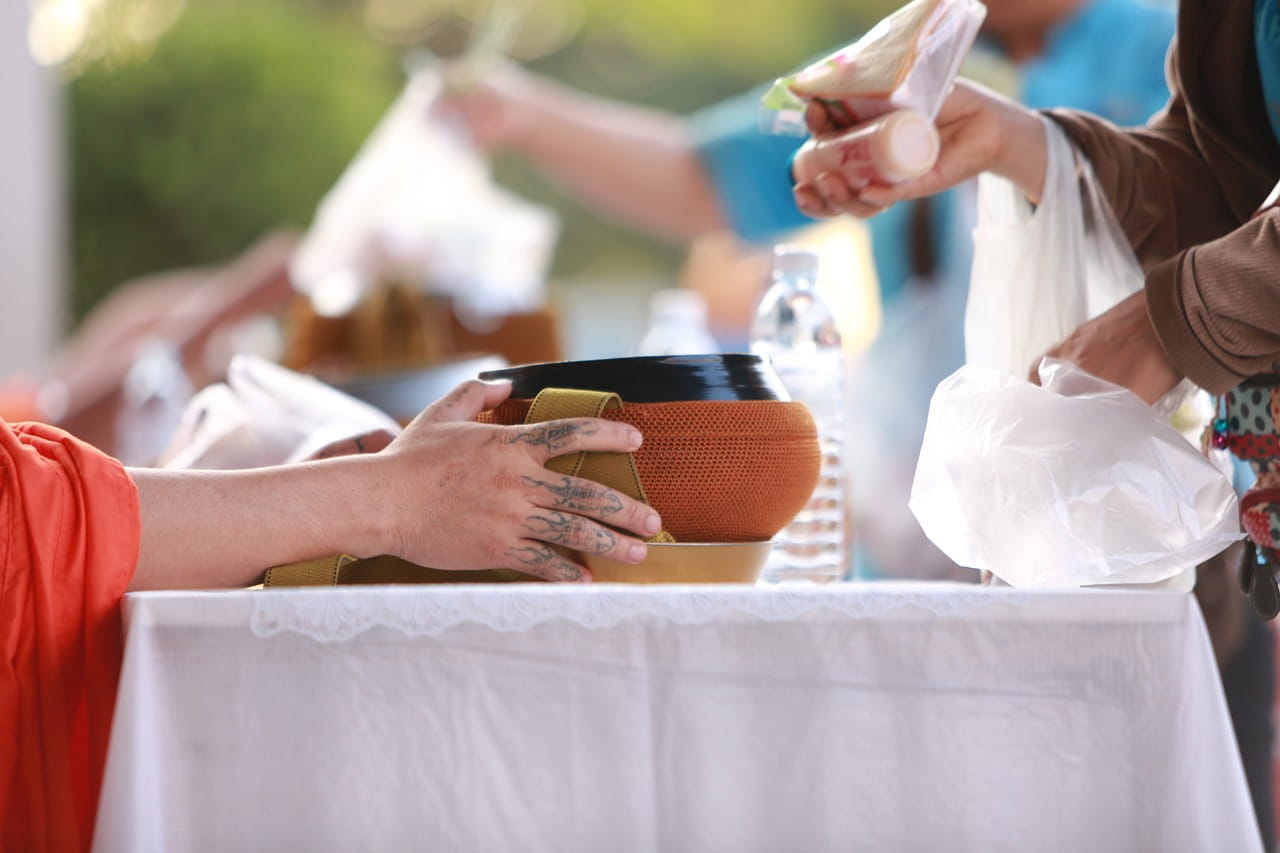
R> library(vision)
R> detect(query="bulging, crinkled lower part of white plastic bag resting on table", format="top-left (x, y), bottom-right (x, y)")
top-left (910, 359), bottom-right (1240, 588)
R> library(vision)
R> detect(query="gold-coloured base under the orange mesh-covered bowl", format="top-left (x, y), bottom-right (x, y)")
top-left (582, 542), bottom-right (771, 584)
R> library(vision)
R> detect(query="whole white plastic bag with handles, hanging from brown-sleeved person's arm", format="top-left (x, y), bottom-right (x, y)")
top-left (910, 119), bottom-right (1240, 589)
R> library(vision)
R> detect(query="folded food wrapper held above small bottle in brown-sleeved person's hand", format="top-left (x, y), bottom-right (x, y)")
top-left (762, 0), bottom-right (987, 136)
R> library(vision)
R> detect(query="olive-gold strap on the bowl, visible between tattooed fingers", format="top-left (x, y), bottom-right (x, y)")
top-left (525, 388), bottom-right (676, 542)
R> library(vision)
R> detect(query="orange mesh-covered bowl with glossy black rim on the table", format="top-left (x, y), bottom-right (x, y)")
top-left (480, 353), bottom-right (822, 543)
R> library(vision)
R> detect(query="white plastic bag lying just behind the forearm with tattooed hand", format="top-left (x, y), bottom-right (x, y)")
top-left (161, 355), bottom-right (401, 470)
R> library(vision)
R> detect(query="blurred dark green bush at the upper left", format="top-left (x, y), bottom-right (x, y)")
top-left (68, 0), bottom-right (399, 319)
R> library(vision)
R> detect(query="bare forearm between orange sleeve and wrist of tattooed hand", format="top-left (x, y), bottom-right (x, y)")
top-left (129, 456), bottom-right (389, 589)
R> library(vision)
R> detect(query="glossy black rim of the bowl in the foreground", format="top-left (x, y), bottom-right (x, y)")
top-left (480, 353), bottom-right (791, 403)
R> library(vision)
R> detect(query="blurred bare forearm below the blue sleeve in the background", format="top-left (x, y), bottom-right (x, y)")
top-left (513, 81), bottom-right (727, 240)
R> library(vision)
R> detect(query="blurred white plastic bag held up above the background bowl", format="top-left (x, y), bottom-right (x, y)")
top-left (289, 68), bottom-right (559, 319)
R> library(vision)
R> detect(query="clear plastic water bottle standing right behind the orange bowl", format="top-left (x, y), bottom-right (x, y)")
top-left (751, 246), bottom-right (850, 583)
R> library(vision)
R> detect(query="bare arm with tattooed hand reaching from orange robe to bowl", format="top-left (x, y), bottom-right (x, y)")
top-left (129, 382), bottom-right (660, 589)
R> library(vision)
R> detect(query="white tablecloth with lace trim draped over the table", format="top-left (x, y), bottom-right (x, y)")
top-left (95, 584), bottom-right (1261, 853)
